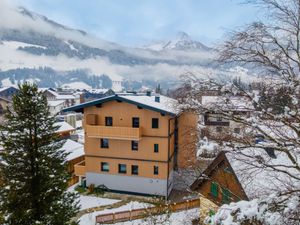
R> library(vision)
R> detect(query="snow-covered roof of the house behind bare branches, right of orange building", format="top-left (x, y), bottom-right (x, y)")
top-left (201, 96), bottom-right (254, 111)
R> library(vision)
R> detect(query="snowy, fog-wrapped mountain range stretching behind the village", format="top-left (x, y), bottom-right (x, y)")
top-left (0, 1), bottom-right (253, 90)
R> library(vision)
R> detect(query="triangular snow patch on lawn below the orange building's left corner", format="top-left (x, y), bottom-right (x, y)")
top-left (68, 184), bottom-right (120, 210)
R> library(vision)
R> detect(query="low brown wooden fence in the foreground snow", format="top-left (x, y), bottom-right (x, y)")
top-left (96, 199), bottom-right (200, 225)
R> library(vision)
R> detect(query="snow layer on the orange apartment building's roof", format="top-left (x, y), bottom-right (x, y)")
top-left (120, 95), bottom-right (179, 114)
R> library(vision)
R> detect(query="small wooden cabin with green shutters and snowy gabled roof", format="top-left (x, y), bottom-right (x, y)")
top-left (191, 148), bottom-right (299, 205)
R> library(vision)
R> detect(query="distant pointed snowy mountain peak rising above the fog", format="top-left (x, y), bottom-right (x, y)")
top-left (143, 32), bottom-right (212, 52)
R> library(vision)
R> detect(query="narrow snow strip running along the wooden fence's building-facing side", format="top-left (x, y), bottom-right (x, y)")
top-left (79, 201), bottom-right (151, 225)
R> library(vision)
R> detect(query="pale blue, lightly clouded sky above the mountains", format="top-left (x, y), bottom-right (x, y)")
top-left (12, 0), bottom-right (257, 46)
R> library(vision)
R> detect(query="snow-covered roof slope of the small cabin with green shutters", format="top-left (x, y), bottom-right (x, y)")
top-left (225, 148), bottom-right (300, 199)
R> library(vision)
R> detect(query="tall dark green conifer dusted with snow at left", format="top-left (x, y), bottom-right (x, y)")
top-left (0, 83), bottom-right (78, 225)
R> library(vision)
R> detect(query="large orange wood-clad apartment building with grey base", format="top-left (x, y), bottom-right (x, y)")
top-left (64, 93), bottom-right (195, 197)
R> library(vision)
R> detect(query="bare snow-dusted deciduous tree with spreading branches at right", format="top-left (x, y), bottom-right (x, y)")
top-left (177, 0), bottom-right (300, 224)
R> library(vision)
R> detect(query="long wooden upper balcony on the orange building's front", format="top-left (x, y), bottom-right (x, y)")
top-left (85, 125), bottom-right (142, 141)
